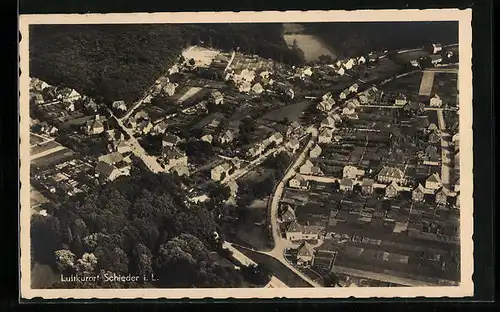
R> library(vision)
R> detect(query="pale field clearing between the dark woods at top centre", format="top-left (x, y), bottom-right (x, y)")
top-left (284, 34), bottom-right (336, 62)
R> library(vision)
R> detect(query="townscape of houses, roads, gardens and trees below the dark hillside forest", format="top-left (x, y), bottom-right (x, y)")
top-left (29, 24), bottom-right (460, 288)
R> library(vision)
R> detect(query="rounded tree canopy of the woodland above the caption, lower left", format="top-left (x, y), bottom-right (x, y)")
top-left (31, 172), bottom-right (250, 288)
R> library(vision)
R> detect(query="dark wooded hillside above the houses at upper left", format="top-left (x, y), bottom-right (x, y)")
top-left (30, 24), bottom-right (301, 102)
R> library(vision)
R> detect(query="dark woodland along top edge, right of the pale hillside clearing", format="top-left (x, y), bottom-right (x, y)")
top-left (303, 22), bottom-right (458, 57)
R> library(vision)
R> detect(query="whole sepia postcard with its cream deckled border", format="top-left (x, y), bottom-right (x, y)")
top-left (19, 9), bottom-right (473, 299)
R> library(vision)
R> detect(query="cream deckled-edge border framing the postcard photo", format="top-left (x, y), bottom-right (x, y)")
top-left (19, 9), bottom-right (474, 299)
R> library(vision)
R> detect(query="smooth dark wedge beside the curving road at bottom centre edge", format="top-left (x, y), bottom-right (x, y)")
top-left (234, 246), bottom-right (311, 287)
